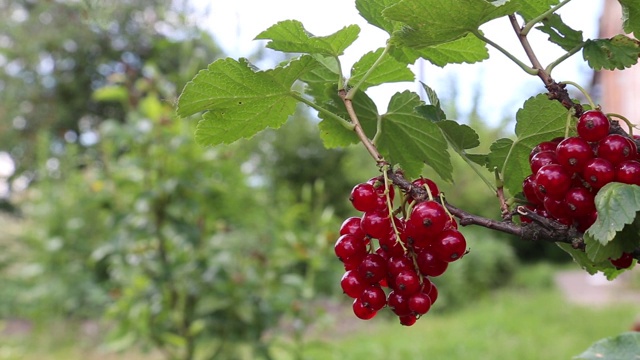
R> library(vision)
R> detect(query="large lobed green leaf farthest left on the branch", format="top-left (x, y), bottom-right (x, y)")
top-left (178, 56), bottom-right (318, 145)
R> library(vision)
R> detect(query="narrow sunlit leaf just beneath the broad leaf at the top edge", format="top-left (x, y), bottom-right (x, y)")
top-left (391, 34), bottom-right (489, 67)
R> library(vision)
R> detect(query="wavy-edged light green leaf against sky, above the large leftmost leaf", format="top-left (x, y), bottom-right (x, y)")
top-left (256, 20), bottom-right (360, 56)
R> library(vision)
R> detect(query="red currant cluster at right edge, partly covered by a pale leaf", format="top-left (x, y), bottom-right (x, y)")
top-left (521, 110), bottom-right (640, 267)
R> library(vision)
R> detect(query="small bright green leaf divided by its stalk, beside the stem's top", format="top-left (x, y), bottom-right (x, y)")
top-left (349, 48), bottom-right (414, 90)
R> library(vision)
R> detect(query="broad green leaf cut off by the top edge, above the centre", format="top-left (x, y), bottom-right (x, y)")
top-left (382, 0), bottom-right (519, 48)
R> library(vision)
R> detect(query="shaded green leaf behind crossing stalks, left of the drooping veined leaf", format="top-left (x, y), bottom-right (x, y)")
top-left (318, 87), bottom-right (378, 149)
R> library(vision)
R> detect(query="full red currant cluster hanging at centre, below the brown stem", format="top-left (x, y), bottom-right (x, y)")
top-left (334, 177), bottom-right (467, 326)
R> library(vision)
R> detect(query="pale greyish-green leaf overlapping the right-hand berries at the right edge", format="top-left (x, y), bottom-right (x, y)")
top-left (585, 182), bottom-right (640, 245)
